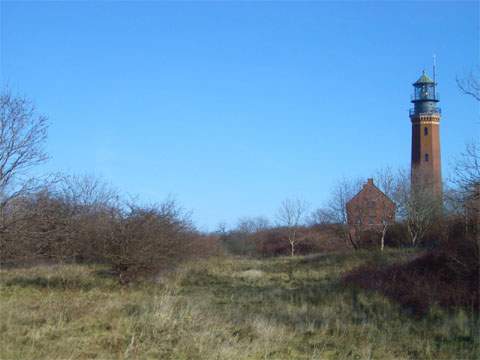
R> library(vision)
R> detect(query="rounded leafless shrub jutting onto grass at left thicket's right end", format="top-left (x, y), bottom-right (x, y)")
top-left (105, 199), bottom-right (197, 282)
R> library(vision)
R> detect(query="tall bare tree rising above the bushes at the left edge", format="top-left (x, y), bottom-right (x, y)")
top-left (0, 90), bottom-right (48, 232)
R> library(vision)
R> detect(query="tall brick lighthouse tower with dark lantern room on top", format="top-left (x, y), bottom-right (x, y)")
top-left (410, 68), bottom-right (442, 196)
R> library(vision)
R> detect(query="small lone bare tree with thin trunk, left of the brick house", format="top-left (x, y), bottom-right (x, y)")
top-left (277, 199), bottom-right (308, 256)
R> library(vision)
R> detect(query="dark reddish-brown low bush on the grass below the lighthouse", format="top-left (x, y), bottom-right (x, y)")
top-left (343, 237), bottom-right (480, 314)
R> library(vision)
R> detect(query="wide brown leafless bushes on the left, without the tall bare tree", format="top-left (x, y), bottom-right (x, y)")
top-left (0, 177), bottom-right (219, 283)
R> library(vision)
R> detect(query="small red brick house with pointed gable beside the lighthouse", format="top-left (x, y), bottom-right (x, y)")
top-left (347, 179), bottom-right (395, 231)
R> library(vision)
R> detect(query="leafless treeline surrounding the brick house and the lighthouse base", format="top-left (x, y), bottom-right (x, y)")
top-left (218, 153), bottom-right (480, 256)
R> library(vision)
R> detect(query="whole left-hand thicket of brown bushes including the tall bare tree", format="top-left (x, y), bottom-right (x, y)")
top-left (0, 91), bottom-right (216, 282)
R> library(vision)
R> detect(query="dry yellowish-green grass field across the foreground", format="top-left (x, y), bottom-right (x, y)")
top-left (0, 251), bottom-right (479, 359)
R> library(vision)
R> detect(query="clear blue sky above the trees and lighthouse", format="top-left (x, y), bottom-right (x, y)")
top-left (0, 1), bottom-right (480, 229)
